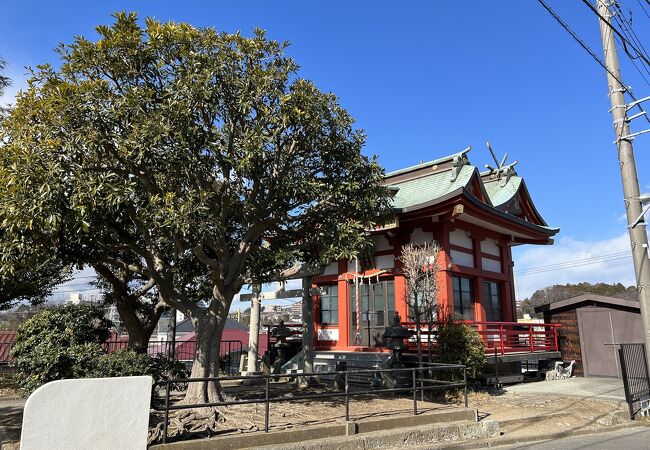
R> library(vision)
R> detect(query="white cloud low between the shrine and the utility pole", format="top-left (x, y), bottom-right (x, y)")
top-left (513, 232), bottom-right (636, 300)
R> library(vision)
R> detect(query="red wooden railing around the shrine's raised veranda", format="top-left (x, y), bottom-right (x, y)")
top-left (403, 320), bottom-right (560, 355)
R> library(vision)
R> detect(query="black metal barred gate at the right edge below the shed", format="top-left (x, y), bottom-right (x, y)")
top-left (618, 344), bottom-right (650, 419)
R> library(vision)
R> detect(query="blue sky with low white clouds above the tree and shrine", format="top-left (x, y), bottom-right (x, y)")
top-left (0, 0), bottom-right (650, 298)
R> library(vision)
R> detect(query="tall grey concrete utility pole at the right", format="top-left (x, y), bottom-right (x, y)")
top-left (598, 0), bottom-right (650, 361)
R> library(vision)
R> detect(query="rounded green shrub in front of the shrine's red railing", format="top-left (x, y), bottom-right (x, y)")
top-left (436, 318), bottom-right (486, 378)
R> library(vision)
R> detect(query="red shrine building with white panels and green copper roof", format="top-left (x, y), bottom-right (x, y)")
top-left (313, 149), bottom-right (559, 354)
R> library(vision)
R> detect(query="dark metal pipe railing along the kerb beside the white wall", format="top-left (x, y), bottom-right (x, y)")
top-left (152, 363), bottom-right (468, 444)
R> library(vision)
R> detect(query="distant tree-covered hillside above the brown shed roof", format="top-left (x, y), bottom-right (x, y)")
top-left (517, 282), bottom-right (639, 319)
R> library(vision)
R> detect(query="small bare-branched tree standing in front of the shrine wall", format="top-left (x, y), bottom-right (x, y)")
top-left (399, 241), bottom-right (440, 363)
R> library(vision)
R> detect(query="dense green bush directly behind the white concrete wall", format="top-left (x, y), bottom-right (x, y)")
top-left (11, 305), bottom-right (187, 395)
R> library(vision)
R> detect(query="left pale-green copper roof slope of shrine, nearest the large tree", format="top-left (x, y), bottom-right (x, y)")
top-left (390, 163), bottom-right (477, 209)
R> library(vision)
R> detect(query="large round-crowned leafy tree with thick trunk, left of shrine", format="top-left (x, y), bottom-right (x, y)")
top-left (0, 13), bottom-right (389, 401)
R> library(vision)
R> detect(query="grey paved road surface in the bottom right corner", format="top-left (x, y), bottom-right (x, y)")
top-left (493, 427), bottom-right (650, 450)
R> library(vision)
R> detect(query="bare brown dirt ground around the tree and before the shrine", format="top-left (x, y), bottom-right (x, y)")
top-left (0, 378), bottom-right (627, 449)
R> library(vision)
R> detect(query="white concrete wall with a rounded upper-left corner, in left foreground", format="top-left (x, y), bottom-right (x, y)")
top-left (20, 377), bottom-right (153, 450)
